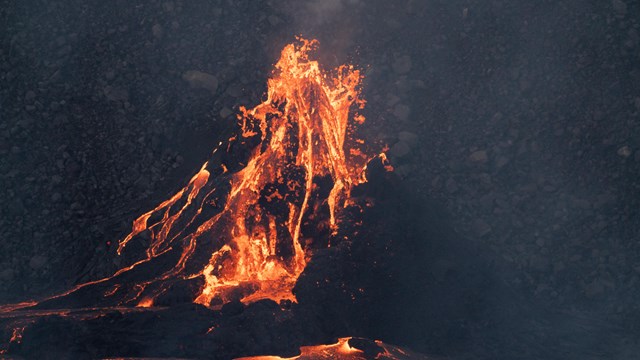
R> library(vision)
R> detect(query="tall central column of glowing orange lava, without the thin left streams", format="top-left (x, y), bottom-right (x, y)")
top-left (190, 40), bottom-right (366, 304)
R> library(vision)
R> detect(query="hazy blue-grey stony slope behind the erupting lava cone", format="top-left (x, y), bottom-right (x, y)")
top-left (0, 0), bottom-right (640, 359)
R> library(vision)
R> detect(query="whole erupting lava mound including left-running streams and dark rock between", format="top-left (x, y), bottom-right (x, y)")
top-left (18, 39), bottom-right (371, 308)
